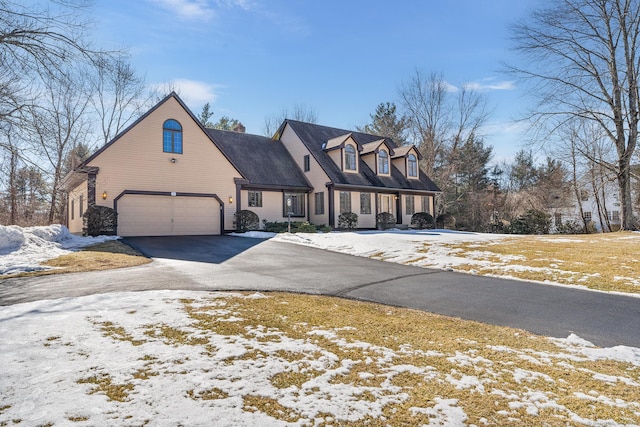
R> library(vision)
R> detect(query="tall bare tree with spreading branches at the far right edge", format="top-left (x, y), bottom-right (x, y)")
top-left (511, 0), bottom-right (640, 230)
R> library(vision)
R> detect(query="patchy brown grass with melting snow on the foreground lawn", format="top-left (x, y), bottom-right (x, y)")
top-left (0, 293), bottom-right (640, 426)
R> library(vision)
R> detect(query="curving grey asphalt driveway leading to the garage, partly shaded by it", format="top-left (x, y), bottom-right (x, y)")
top-left (0, 236), bottom-right (640, 347)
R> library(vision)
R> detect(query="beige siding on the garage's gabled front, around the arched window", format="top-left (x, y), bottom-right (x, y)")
top-left (89, 98), bottom-right (241, 234)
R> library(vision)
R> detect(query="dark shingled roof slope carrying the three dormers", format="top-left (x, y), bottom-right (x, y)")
top-left (283, 120), bottom-right (440, 192)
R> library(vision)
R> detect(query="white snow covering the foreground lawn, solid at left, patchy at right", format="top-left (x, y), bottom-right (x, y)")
top-left (0, 291), bottom-right (640, 426)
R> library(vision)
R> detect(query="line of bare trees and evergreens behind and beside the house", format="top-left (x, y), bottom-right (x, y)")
top-left (0, 0), bottom-right (640, 231)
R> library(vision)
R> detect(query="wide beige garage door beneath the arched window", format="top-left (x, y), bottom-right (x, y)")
top-left (118, 194), bottom-right (220, 236)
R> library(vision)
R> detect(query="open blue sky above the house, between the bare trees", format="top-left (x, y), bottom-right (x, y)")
top-left (93, 0), bottom-right (537, 161)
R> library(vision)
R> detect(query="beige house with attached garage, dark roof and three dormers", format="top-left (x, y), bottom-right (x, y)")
top-left (63, 93), bottom-right (440, 236)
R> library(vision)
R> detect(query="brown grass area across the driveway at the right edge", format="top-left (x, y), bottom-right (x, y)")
top-left (438, 232), bottom-right (640, 293)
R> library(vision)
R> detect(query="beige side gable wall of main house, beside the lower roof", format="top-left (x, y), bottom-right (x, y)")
top-left (280, 126), bottom-right (330, 225)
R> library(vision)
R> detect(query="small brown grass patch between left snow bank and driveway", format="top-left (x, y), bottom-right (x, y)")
top-left (0, 240), bottom-right (151, 278)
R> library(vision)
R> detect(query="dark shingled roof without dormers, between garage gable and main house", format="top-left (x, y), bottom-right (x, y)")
top-left (205, 129), bottom-right (311, 190)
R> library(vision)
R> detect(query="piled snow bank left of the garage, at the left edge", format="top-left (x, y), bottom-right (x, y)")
top-left (0, 224), bottom-right (118, 276)
